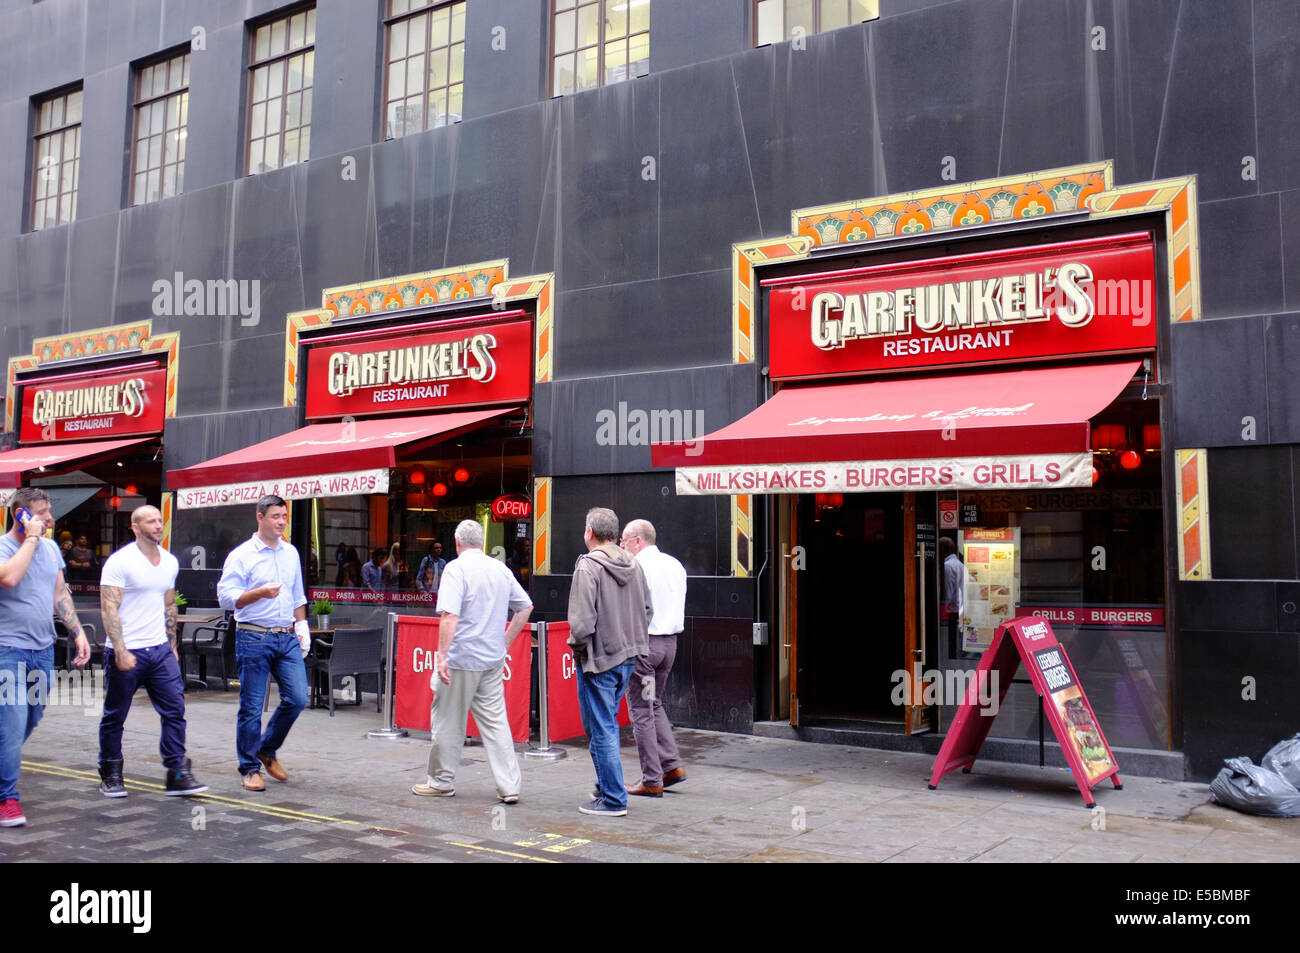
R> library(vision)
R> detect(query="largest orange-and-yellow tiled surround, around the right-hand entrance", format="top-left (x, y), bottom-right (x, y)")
top-left (732, 161), bottom-right (1210, 580)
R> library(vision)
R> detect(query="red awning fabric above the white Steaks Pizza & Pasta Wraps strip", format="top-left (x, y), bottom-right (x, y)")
top-left (166, 407), bottom-right (519, 495)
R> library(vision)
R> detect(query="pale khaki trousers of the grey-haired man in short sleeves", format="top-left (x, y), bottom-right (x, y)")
top-left (429, 666), bottom-right (523, 797)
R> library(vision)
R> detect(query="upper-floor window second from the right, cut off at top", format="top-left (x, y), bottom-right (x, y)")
top-left (551, 0), bottom-right (650, 96)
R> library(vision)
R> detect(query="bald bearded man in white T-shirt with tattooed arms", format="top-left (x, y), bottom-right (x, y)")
top-left (99, 506), bottom-right (208, 797)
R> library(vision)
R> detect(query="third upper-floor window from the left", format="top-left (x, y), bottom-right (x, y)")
top-left (246, 7), bottom-right (316, 174)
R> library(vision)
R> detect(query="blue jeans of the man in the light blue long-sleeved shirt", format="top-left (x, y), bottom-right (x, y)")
top-left (235, 627), bottom-right (307, 775)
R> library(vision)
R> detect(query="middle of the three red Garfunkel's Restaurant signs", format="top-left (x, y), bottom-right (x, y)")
top-left (307, 315), bottom-right (533, 419)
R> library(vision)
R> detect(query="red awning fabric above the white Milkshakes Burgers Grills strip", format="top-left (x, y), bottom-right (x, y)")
top-left (650, 360), bottom-right (1139, 467)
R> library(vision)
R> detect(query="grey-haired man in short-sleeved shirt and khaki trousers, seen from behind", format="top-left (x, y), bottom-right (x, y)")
top-left (411, 520), bottom-right (533, 803)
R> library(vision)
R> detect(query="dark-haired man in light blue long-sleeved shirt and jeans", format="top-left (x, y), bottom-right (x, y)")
top-left (217, 495), bottom-right (311, 790)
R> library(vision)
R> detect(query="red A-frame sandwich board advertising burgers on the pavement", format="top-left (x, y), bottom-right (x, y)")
top-left (930, 615), bottom-right (1123, 807)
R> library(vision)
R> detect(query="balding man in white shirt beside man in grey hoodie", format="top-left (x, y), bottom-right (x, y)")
top-left (620, 520), bottom-right (686, 797)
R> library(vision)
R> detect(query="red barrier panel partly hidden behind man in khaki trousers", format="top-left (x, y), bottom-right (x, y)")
top-left (393, 615), bottom-right (533, 741)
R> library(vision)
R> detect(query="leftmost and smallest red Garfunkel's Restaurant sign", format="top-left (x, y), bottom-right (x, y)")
top-left (20, 368), bottom-right (166, 443)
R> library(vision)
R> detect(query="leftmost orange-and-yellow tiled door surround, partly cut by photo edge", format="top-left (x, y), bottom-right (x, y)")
top-left (4, 321), bottom-right (181, 549)
